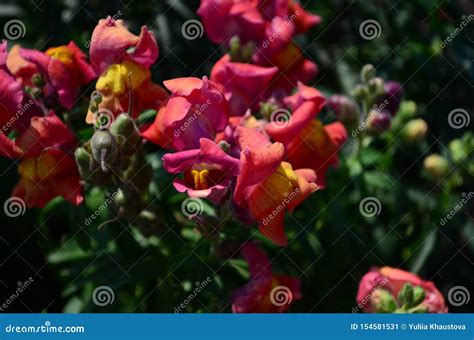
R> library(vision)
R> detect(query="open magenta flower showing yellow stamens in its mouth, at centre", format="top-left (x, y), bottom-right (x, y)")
top-left (163, 138), bottom-right (239, 204)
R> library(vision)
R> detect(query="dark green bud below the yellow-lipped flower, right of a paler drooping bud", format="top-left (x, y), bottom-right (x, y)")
top-left (109, 113), bottom-right (141, 154)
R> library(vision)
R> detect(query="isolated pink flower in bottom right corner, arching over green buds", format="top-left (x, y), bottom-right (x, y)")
top-left (357, 267), bottom-right (448, 313)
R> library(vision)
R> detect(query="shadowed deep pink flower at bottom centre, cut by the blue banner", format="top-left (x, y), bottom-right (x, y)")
top-left (232, 243), bottom-right (302, 313)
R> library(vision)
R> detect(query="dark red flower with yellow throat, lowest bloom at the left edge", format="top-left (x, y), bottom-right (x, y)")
top-left (0, 112), bottom-right (83, 207)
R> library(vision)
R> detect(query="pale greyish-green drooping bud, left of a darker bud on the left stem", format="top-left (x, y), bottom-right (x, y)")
top-left (90, 130), bottom-right (117, 172)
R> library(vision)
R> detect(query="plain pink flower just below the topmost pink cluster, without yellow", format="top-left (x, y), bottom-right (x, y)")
top-left (211, 54), bottom-right (278, 116)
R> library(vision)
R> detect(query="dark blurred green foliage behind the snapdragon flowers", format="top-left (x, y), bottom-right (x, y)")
top-left (0, 0), bottom-right (474, 313)
